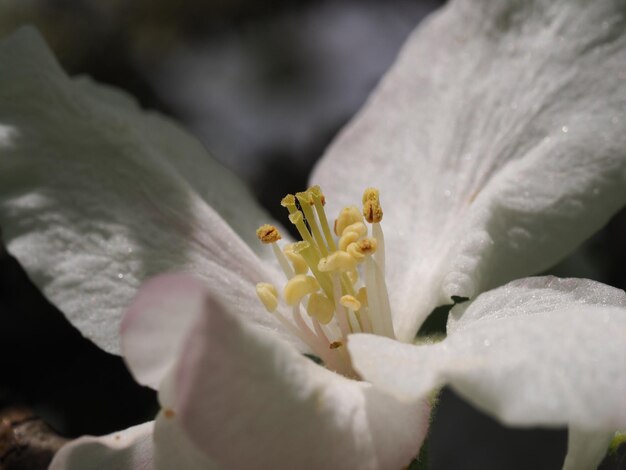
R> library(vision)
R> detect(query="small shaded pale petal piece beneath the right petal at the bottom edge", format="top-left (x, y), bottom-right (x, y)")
top-left (563, 429), bottom-right (613, 470)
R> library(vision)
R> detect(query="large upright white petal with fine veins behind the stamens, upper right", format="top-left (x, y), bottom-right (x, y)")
top-left (313, 0), bottom-right (626, 341)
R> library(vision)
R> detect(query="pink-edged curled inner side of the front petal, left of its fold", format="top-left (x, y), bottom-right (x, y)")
top-left (120, 274), bottom-right (303, 389)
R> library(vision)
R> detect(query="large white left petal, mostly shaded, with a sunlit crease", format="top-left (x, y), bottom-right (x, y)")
top-left (0, 29), bottom-right (282, 352)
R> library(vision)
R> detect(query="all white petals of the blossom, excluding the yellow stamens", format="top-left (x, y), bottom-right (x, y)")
top-left (0, 0), bottom-right (626, 468)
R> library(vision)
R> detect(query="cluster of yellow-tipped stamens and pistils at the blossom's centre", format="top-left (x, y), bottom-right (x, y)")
top-left (256, 186), bottom-right (395, 377)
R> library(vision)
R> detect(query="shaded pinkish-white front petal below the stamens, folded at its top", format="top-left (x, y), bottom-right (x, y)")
top-left (160, 290), bottom-right (429, 469)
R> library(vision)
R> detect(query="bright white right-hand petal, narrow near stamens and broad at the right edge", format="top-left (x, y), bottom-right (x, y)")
top-left (348, 278), bottom-right (626, 432)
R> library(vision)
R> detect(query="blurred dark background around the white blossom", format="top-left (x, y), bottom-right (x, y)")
top-left (0, 0), bottom-right (626, 470)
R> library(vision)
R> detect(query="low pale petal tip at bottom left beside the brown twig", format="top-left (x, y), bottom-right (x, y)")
top-left (49, 422), bottom-right (154, 470)
